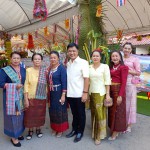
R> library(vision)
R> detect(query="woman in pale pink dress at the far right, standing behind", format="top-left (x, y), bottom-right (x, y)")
top-left (123, 43), bottom-right (140, 132)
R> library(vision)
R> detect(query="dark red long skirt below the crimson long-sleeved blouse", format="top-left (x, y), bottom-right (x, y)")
top-left (108, 85), bottom-right (127, 132)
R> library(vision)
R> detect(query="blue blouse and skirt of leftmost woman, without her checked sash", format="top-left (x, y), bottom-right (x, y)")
top-left (0, 67), bottom-right (26, 138)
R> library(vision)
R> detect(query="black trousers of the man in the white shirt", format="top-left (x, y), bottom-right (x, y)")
top-left (67, 97), bottom-right (86, 134)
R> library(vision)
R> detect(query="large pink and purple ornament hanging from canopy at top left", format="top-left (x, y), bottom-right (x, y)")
top-left (33, 0), bottom-right (48, 21)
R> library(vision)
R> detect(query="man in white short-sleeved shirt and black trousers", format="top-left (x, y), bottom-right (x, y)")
top-left (66, 43), bottom-right (89, 143)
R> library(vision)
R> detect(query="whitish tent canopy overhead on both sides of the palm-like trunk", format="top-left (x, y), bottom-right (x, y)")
top-left (0, 0), bottom-right (150, 35)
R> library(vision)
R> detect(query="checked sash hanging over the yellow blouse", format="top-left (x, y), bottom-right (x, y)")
top-left (35, 66), bottom-right (47, 100)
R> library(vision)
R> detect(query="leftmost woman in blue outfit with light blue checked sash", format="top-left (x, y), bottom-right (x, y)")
top-left (0, 52), bottom-right (26, 147)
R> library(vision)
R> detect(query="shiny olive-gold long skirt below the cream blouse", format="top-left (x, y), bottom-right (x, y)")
top-left (90, 93), bottom-right (107, 141)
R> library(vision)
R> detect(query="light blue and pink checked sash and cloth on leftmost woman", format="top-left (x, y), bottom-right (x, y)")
top-left (2, 66), bottom-right (24, 115)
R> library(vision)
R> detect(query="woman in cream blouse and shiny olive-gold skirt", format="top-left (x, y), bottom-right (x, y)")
top-left (89, 50), bottom-right (111, 145)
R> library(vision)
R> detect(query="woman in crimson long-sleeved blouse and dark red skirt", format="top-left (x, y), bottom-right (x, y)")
top-left (108, 51), bottom-right (128, 140)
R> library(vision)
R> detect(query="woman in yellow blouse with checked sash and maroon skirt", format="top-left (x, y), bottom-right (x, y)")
top-left (24, 53), bottom-right (47, 140)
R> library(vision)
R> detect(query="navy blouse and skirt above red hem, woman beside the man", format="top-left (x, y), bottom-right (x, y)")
top-left (49, 65), bottom-right (68, 124)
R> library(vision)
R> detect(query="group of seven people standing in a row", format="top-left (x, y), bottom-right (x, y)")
top-left (0, 43), bottom-right (140, 147)
